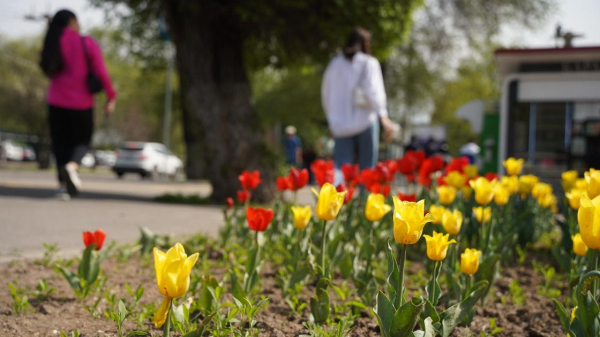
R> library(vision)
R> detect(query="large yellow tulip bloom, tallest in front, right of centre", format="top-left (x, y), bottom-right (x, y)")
top-left (394, 197), bottom-right (435, 245)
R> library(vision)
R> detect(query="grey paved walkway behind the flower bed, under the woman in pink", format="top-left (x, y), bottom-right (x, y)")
top-left (0, 168), bottom-right (223, 262)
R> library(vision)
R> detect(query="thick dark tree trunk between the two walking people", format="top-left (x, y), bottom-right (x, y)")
top-left (163, 0), bottom-right (275, 201)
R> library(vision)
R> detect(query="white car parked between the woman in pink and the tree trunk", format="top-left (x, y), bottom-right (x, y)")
top-left (112, 142), bottom-right (183, 179)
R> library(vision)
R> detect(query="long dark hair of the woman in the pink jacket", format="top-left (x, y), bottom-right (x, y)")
top-left (40, 9), bottom-right (77, 77)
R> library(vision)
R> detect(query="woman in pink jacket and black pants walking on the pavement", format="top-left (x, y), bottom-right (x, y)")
top-left (40, 10), bottom-right (116, 199)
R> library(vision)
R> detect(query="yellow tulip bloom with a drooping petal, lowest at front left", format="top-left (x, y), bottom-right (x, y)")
top-left (154, 243), bottom-right (198, 328)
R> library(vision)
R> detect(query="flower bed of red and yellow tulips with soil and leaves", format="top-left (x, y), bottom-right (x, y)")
top-left (0, 152), bottom-right (600, 337)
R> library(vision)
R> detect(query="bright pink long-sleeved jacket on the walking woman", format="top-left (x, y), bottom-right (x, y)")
top-left (47, 28), bottom-right (117, 110)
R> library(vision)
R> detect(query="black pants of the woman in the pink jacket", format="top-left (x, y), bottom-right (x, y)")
top-left (48, 105), bottom-right (94, 182)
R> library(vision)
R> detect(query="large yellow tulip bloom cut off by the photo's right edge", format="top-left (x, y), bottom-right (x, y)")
top-left (577, 194), bottom-right (600, 249)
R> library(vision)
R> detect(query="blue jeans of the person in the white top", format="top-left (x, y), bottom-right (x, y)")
top-left (333, 120), bottom-right (379, 186)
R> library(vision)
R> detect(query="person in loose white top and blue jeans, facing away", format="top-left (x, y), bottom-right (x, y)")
top-left (321, 27), bottom-right (394, 178)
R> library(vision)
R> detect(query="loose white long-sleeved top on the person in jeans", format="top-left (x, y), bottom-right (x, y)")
top-left (321, 52), bottom-right (388, 137)
